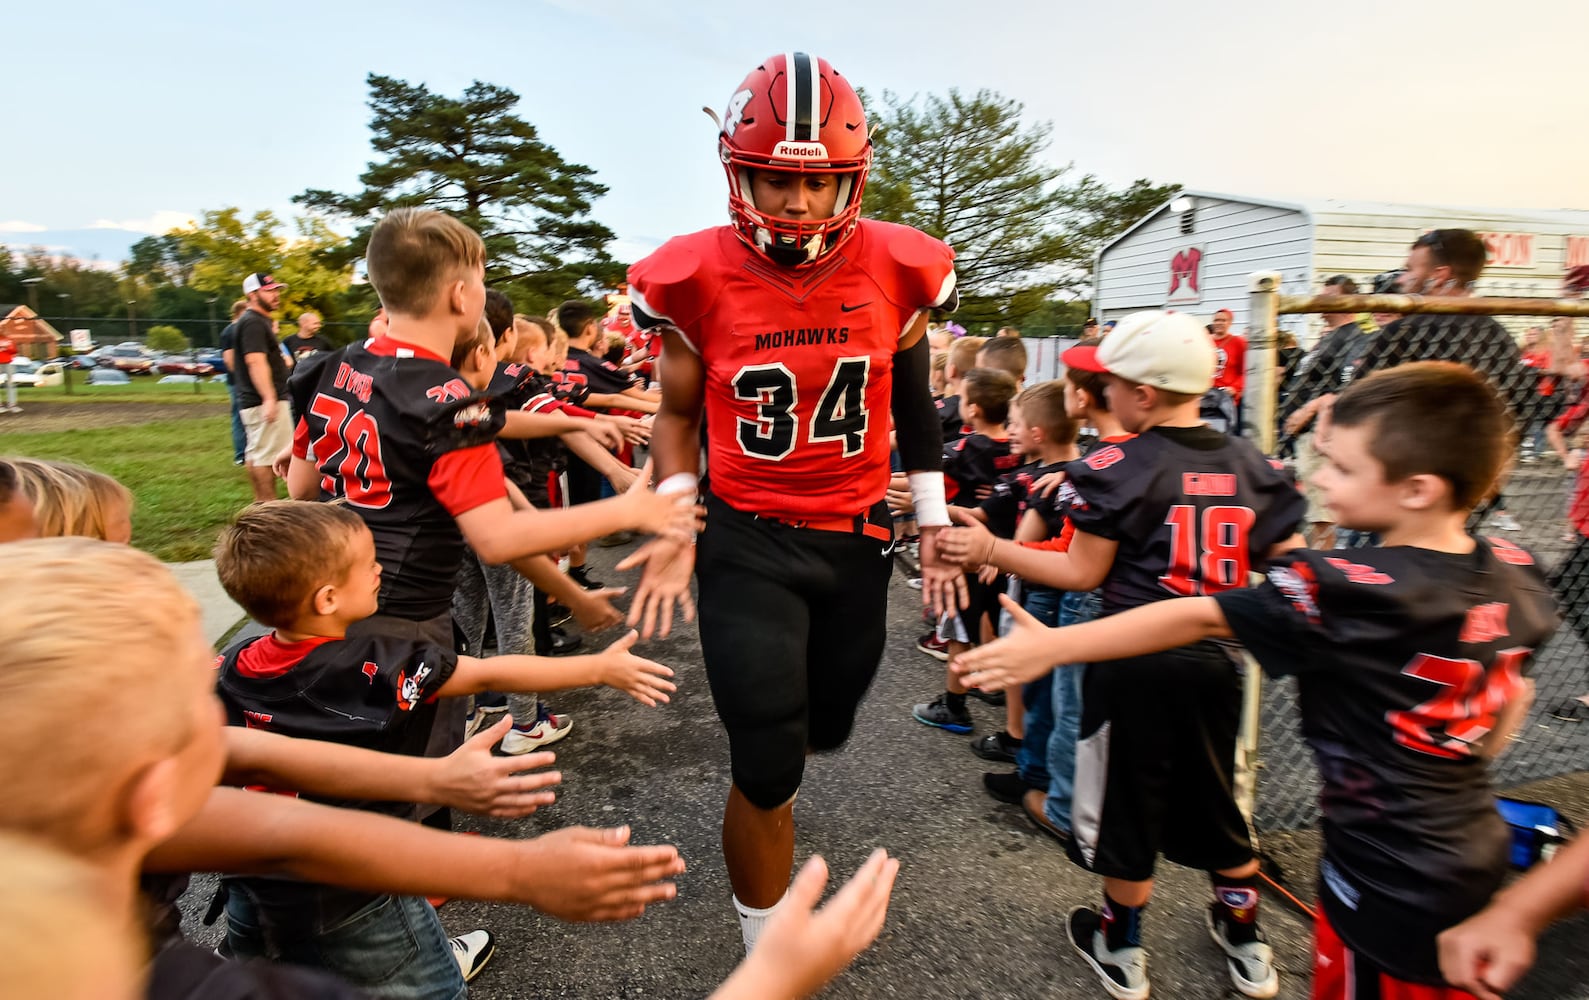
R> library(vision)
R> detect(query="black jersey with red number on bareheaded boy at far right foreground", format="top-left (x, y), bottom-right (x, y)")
top-left (1217, 539), bottom-right (1559, 970)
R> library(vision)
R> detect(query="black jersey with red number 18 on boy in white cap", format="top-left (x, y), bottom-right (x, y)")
top-left (1058, 426), bottom-right (1306, 615)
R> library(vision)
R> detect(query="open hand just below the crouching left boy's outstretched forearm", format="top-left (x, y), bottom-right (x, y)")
top-left (424, 714), bottom-right (563, 819)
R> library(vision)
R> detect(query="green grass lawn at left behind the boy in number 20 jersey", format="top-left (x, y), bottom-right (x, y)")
top-left (0, 410), bottom-right (253, 563)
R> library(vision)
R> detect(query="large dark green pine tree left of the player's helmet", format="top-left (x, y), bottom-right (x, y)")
top-left (294, 73), bottom-right (623, 312)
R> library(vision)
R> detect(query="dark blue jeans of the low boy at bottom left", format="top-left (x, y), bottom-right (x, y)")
top-left (226, 882), bottom-right (469, 1000)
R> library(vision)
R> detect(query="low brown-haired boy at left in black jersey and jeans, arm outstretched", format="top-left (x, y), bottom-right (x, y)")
top-left (216, 501), bottom-right (674, 1000)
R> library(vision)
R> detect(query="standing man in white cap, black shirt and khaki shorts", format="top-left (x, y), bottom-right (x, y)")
top-left (232, 273), bottom-right (292, 501)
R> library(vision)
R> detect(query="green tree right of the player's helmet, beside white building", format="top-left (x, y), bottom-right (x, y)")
top-left (866, 89), bottom-right (1176, 326)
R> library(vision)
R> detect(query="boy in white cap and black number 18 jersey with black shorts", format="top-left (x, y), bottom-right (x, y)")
top-left (941, 312), bottom-right (1303, 998)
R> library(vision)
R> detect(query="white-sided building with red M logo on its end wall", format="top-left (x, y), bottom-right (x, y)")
top-left (1093, 191), bottom-right (1589, 343)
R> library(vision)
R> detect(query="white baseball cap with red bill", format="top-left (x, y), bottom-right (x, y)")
top-left (1060, 310), bottom-right (1214, 396)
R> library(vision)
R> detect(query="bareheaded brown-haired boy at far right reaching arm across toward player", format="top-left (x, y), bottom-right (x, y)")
top-left (960, 362), bottom-right (1557, 1000)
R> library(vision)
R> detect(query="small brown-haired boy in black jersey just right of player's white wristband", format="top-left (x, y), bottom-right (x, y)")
top-left (910, 369), bottom-right (1020, 733)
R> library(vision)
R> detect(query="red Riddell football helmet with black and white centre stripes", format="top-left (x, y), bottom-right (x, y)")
top-left (718, 52), bottom-right (872, 267)
